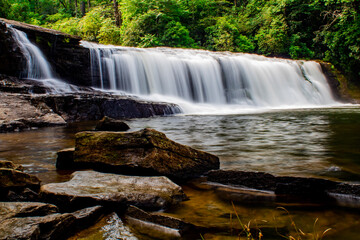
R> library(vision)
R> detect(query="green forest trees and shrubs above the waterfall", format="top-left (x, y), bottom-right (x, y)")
top-left (0, 0), bottom-right (360, 83)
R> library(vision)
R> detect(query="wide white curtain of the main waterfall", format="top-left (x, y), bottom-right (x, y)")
top-left (82, 41), bottom-right (336, 112)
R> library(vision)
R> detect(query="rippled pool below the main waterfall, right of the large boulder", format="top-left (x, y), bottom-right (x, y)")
top-left (129, 108), bottom-right (360, 181)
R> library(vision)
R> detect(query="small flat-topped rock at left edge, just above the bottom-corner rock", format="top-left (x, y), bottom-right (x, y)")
top-left (0, 202), bottom-right (58, 222)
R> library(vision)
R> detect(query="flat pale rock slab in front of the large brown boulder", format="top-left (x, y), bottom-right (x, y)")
top-left (41, 171), bottom-right (186, 210)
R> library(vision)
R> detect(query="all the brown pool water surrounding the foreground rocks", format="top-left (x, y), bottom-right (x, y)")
top-left (0, 108), bottom-right (360, 240)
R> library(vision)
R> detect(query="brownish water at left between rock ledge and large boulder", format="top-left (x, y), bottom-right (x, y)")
top-left (0, 123), bottom-right (93, 183)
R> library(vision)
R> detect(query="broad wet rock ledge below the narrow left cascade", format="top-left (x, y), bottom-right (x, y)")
top-left (0, 75), bottom-right (181, 132)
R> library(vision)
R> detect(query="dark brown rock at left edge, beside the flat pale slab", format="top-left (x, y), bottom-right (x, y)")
top-left (0, 168), bottom-right (40, 194)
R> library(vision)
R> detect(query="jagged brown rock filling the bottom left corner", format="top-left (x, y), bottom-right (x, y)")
top-left (0, 206), bottom-right (102, 239)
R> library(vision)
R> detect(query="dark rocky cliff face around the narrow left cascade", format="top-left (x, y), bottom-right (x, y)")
top-left (0, 18), bottom-right (96, 86)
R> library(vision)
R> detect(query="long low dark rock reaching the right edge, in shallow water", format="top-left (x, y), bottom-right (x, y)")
top-left (207, 170), bottom-right (360, 207)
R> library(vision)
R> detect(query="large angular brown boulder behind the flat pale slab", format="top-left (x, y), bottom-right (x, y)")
top-left (74, 129), bottom-right (220, 179)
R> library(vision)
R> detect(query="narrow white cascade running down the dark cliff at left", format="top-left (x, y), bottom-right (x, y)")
top-left (7, 25), bottom-right (77, 93)
